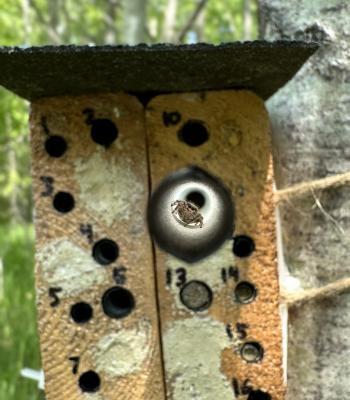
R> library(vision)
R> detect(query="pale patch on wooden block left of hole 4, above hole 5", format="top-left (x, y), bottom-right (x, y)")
top-left (37, 239), bottom-right (107, 297)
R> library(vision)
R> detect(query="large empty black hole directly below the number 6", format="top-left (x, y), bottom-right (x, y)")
top-left (102, 286), bottom-right (135, 319)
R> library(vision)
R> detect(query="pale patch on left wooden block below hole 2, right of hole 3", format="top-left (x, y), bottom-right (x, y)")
top-left (75, 151), bottom-right (144, 226)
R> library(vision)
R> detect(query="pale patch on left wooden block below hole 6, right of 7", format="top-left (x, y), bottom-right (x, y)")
top-left (92, 320), bottom-right (151, 377)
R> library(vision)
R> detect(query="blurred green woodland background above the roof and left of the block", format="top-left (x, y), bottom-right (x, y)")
top-left (0, 0), bottom-right (257, 400)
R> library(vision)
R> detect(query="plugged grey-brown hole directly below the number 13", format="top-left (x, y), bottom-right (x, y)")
top-left (180, 280), bottom-right (213, 311)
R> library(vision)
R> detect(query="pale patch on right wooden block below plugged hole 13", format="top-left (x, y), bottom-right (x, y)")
top-left (163, 316), bottom-right (234, 400)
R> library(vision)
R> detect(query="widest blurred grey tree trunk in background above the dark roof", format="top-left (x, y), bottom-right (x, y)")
top-left (124, 0), bottom-right (147, 45)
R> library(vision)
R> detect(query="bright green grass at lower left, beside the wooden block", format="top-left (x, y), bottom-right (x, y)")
top-left (0, 225), bottom-right (40, 400)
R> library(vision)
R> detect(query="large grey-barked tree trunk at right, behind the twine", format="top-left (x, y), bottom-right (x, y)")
top-left (260, 0), bottom-right (350, 400)
